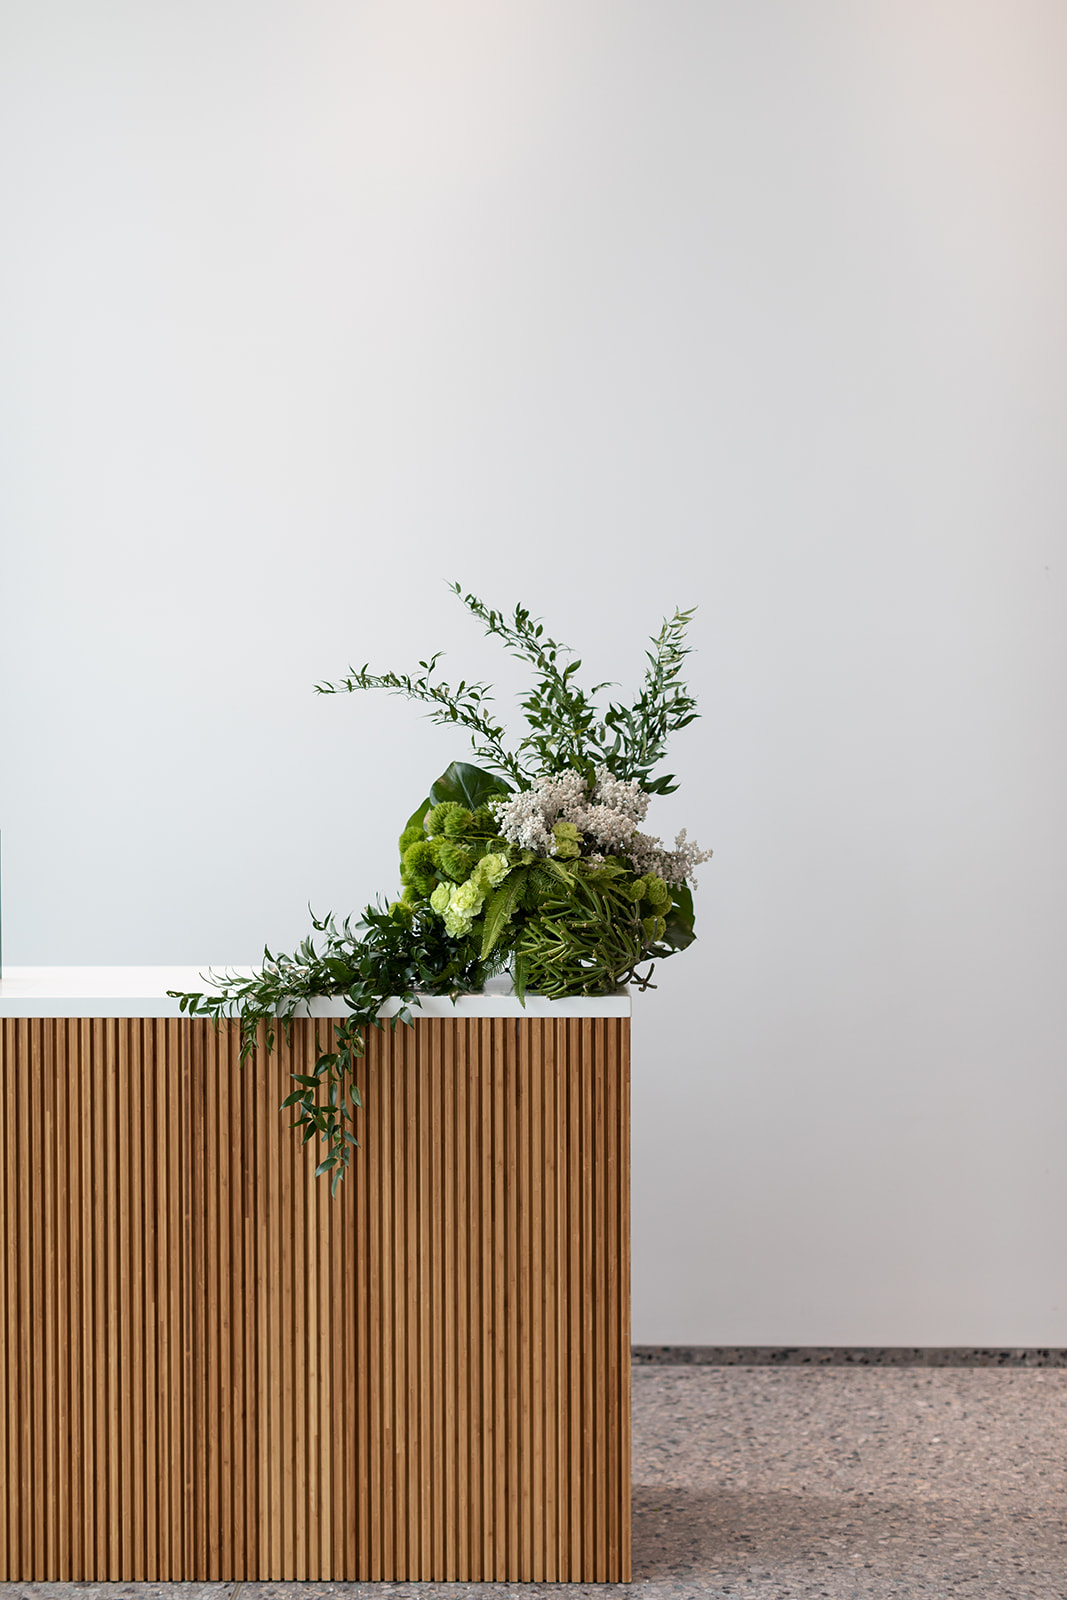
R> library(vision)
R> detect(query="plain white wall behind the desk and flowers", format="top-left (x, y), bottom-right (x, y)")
top-left (0, 0), bottom-right (1067, 1346)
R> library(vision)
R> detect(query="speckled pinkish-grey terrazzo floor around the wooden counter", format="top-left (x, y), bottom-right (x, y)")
top-left (0, 1365), bottom-right (1067, 1600)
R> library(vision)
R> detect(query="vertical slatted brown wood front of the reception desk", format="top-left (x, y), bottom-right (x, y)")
top-left (0, 1018), bottom-right (630, 1582)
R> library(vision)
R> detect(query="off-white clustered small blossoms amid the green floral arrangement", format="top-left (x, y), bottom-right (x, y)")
top-left (490, 766), bottom-right (712, 888)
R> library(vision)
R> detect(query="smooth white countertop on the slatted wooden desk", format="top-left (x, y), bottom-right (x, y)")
top-left (0, 966), bottom-right (630, 1018)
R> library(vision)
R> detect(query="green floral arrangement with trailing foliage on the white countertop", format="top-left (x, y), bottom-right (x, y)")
top-left (174, 584), bottom-right (710, 1192)
